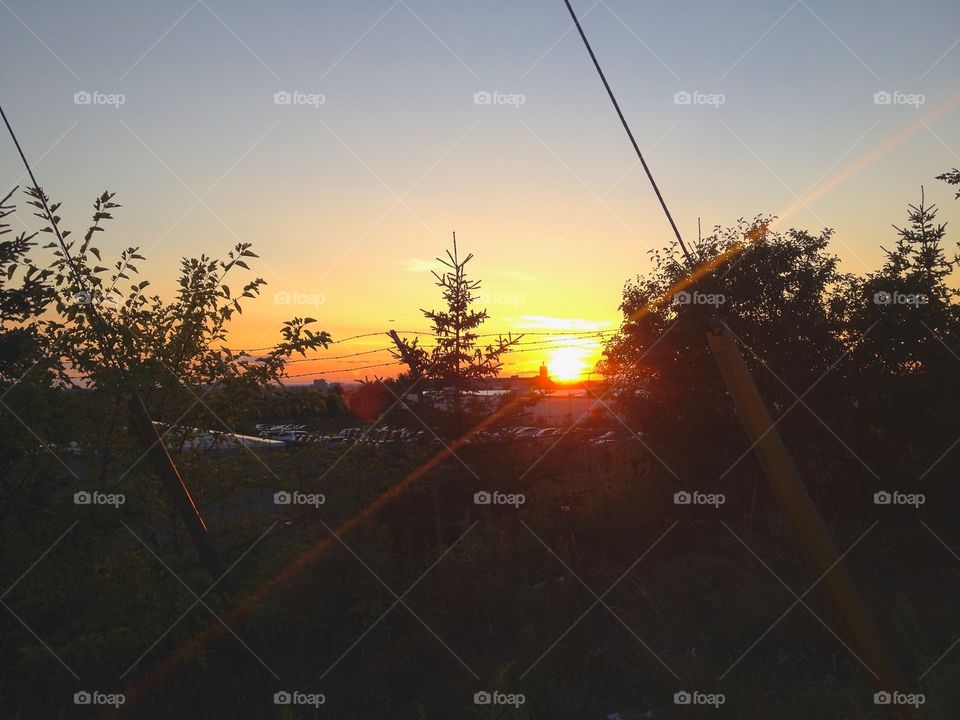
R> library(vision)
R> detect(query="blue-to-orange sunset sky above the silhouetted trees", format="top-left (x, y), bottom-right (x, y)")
top-left (0, 0), bottom-right (960, 380)
